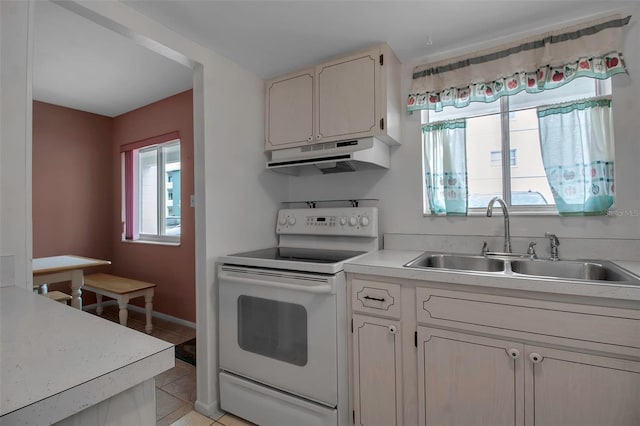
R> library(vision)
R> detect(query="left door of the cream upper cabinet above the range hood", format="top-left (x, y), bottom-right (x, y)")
top-left (265, 68), bottom-right (314, 151)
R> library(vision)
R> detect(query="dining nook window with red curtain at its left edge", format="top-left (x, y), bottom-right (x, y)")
top-left (121, 133), bottom-right (181, 243)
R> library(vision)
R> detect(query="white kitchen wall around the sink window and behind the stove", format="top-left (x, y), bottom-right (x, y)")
top-left (290, 6), bottom-right (640, 260)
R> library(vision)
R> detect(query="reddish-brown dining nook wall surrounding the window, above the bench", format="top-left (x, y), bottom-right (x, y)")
top-left (110, 90), bottom-right (196, 322)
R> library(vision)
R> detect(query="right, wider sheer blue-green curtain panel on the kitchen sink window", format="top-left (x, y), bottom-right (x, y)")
top-left (538, 98), bottom-right (614, 216)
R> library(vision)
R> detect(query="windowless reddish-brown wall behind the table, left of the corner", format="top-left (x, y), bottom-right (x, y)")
top-left (32, 101), bottom-right (114, 259)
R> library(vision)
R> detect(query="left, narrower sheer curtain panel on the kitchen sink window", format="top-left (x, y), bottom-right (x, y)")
top-left (422, 120), bottom-right (469, 215)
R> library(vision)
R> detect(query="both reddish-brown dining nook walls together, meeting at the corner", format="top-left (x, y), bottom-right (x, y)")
top-left (33, 90), bottom-right (196, 322)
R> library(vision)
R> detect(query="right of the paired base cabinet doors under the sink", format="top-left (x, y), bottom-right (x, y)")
top-left (525, 346), bottom-right (640, 426)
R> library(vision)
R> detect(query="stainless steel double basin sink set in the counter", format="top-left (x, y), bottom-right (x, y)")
top-left (404, 252), bottom-right (640, 285)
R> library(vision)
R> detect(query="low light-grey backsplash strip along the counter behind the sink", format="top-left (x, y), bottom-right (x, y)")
top-left (383, 234), bottom-right (640, 261)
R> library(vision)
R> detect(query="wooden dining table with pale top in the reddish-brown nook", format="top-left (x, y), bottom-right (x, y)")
top-left (33, 255), bottom-right (111, 310)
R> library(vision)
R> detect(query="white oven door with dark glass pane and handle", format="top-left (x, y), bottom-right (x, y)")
top-left (218, 265), bottom-right (344, 407)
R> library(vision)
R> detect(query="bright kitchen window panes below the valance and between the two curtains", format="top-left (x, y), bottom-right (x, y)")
top-left (422, 78), bottom-right (611, 214)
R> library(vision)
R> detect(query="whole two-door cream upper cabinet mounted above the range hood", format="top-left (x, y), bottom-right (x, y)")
top-left (265, 44), bottom-right (401, 151)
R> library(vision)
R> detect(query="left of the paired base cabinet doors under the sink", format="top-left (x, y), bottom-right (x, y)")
top-left (418, 327), bottom-right (524, 426)
